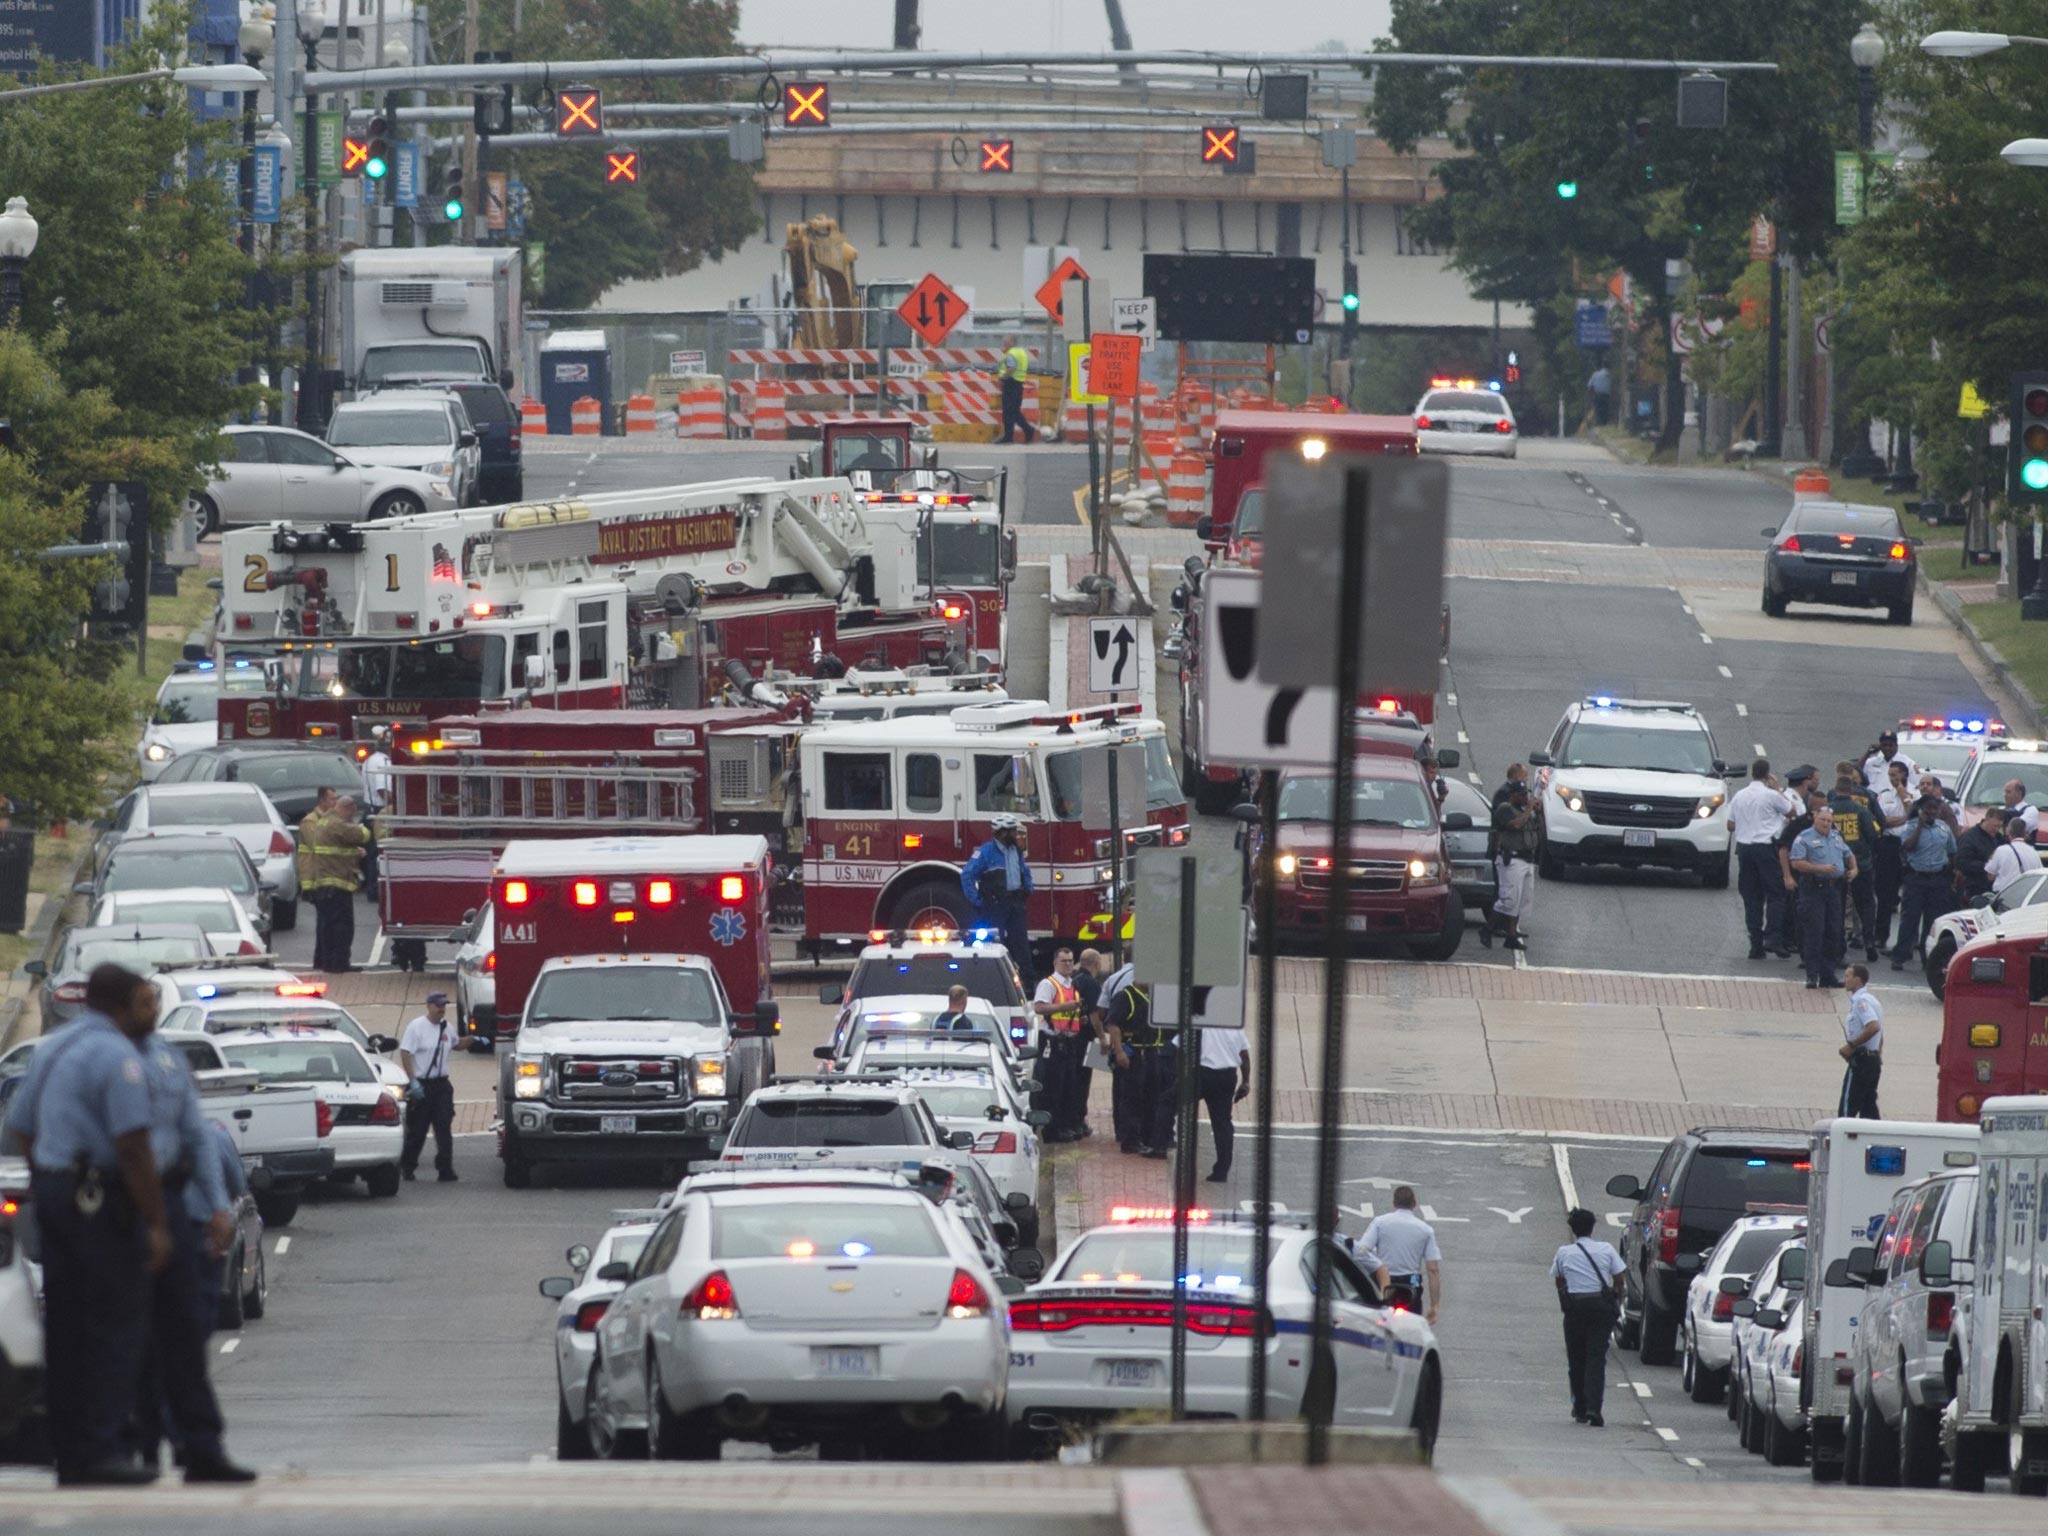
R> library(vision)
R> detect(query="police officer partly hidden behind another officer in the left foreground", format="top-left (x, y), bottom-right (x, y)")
top-left (127, 979), bottom-right (256, 1483)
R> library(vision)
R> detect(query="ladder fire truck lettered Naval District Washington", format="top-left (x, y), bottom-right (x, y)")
top-left (217, 477), bottom-right (1008, 753)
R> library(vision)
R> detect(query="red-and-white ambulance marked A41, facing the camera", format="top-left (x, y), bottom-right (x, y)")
top-left (489, 836), bottom-right (780, 1188)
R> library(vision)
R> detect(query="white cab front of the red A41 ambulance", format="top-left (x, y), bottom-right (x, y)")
top-left (498, 954), bottom-right (774, 1190)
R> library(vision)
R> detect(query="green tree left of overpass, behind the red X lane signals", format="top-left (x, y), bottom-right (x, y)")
top-left (430, 0), bottom-right (758, 309)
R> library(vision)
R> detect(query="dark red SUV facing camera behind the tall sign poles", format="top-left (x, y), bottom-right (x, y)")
top-left (1245, 743), bottom-right (1470, 961)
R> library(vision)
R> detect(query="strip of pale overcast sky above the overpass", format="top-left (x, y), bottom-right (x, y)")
top-left (739, 0), bottom-right (1389, 53)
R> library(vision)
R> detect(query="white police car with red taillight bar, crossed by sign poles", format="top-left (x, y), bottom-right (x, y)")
top-left (1010, 1206), bottom-right (1444, 1456)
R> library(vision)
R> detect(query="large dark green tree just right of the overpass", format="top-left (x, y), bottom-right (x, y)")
top-left (1374, 0), bottom-right (1855, 449)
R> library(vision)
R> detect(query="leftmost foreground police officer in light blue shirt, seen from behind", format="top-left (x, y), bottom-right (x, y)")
top-left (6, 965), bottom-right (172, 1487)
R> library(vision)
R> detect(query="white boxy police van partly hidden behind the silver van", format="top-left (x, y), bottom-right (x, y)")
top-left (1802, 1118), bottom-right (1976, 1483)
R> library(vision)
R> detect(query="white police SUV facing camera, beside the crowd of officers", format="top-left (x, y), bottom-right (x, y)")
top-left (1528, 694), bottom-right (1735, 887)
